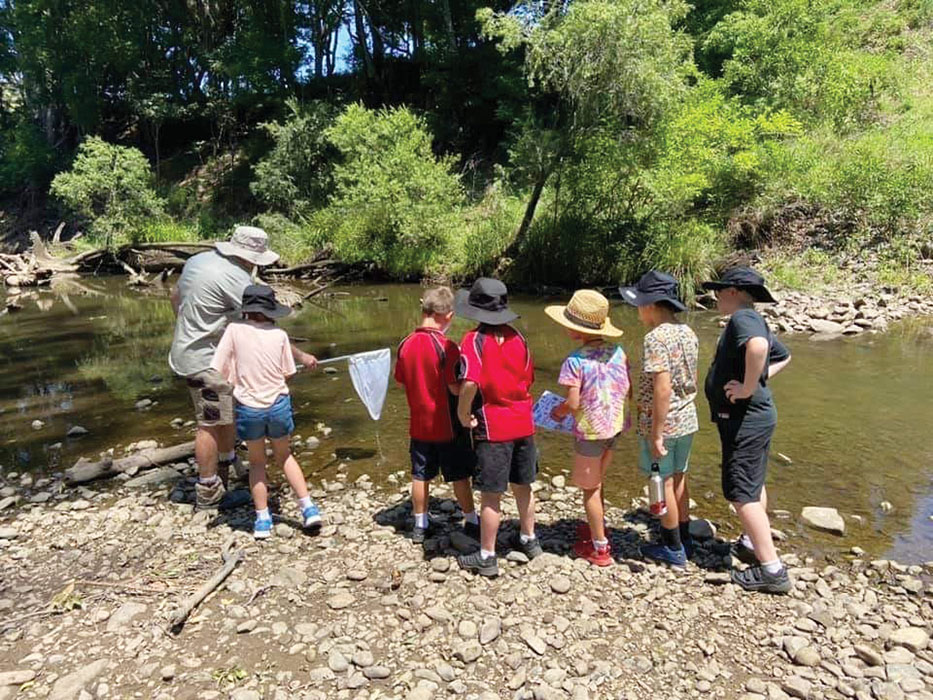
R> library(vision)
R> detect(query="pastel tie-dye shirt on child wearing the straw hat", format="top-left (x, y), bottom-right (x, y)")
top-left (557, 341), bottom-right (632, 440)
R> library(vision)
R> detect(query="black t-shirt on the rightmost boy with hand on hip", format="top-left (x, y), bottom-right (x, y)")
top-left (705, 308), bottom-right (790, 424)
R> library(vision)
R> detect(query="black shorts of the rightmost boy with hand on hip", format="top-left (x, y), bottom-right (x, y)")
top-left (716, 417), bottom-right (777, 503)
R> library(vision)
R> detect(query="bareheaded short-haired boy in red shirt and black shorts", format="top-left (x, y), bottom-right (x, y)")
top-left (395, 287), bottom-right (479, 544)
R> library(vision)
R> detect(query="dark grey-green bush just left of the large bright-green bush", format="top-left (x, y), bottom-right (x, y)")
top-left (250, 100), bottom-right (337, 216)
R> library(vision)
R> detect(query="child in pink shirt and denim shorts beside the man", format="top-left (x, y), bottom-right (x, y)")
top-left (211, 284), bottom-right (321, 539)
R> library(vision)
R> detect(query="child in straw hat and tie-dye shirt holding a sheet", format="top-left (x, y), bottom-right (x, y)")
top-left (544, 289), bottom-right (632, 566)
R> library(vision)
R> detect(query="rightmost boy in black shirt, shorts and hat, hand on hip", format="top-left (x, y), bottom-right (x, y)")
top-left (703, 267), bottom-right (792, 593)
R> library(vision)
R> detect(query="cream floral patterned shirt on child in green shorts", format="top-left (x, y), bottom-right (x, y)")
top-left (638, 323), bottom-right (700, 438)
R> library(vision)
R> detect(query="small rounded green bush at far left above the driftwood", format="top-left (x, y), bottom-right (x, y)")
top-left (50, 136), bottom-right (163, 247)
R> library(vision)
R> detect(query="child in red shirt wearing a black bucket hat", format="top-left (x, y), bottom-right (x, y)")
top-left (456, 278), bottom-right (541, 576)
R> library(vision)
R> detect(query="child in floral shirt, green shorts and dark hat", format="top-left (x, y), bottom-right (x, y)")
top-left (619, 270), bottom-right (699, 569)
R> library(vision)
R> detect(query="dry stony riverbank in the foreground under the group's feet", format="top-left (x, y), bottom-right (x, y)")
top-left (0, 456), bottom-right (933, 700)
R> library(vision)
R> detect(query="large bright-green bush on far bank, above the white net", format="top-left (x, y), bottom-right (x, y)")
top-left (320, 105), bottom-right (463, 278)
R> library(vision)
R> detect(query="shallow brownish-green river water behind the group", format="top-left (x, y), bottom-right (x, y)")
top-left (0, 279), bottom-right (933, 562)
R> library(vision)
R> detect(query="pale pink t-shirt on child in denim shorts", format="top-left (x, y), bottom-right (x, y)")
top-left (211, 321), bottom-right (297, 408)
